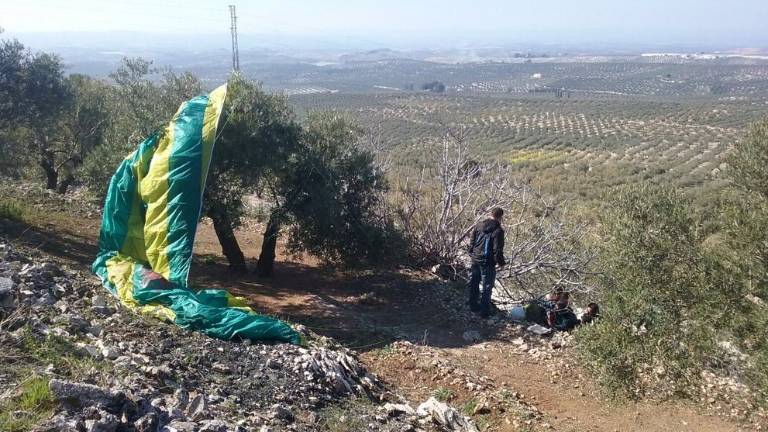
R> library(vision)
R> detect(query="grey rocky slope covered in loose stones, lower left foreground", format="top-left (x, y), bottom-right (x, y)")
top-left (0, 242), bottom-right (486, 432)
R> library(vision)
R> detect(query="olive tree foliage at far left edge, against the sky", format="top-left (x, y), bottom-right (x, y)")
top-left (0, 41), bottom-right (117, 193)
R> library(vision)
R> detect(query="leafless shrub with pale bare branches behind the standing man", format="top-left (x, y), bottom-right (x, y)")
top-left (394, 126), bottom-right (594, 300)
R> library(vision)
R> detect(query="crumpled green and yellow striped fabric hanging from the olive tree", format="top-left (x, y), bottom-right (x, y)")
top-left (92, 85), bottom-right (300, 343)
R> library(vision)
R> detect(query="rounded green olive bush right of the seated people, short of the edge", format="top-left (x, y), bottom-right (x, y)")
top-left (578, 184), bottom-right (743, 397)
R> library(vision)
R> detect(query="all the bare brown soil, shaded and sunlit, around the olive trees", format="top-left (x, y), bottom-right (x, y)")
top-left (0, 190), bottom-right (748, 431)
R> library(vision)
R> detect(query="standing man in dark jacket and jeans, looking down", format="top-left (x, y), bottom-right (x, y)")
top-left (468, 207), bottom-right (507, 318)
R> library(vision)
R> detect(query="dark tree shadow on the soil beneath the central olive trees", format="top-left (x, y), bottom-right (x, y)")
top-left (191, 261), bottom-right (508, 351)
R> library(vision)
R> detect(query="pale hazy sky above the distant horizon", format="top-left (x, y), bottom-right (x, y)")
top-left (0, 0), bottom-right (768, 46)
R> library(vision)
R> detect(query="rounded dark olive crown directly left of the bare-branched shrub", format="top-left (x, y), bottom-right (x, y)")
top-left (278, 113), bottom-right (399, 265)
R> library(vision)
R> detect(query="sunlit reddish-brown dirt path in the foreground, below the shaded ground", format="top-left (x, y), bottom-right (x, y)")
top-left (363, 341), bottom-right (751, 432)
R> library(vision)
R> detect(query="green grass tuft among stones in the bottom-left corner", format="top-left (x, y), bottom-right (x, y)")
top-left (0, 377), bottom-right (55, 432)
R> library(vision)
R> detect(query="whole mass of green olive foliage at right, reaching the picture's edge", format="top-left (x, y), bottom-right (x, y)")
top-left (578, 121), bottom-right (768, 401)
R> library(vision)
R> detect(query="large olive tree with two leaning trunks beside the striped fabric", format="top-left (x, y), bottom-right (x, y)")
top-left (204, 75), bottom-right (400, 276)
